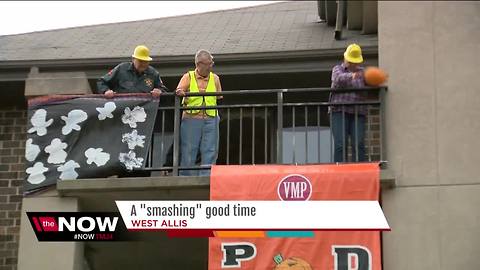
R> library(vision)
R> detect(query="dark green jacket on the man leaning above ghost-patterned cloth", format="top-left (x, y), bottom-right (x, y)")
top-left (97, 62), bottom-right (168, 94)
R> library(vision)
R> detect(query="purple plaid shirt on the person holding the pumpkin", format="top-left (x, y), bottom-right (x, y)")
top-left (329, 63), bottom-right (367, 115)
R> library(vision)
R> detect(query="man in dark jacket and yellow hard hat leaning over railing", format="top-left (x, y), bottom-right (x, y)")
top-left (97, 45), bottom-right (167, 98)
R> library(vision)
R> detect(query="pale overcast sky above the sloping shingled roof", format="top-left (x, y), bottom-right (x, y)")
top-left (0, 1), bottom-right (278, 35)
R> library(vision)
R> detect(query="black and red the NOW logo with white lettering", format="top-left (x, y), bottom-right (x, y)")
top-left (27, 212), bottom-right (126, 241)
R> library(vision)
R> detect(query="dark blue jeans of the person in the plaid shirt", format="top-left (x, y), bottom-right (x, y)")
top-left (331, 112), bottom-right (366, 162)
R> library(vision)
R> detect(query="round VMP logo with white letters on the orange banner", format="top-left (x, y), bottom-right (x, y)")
top-left (277, 174), bottom-right (312, 201)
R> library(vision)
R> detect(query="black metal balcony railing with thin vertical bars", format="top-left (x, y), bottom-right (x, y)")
top-left (144, 87), bottom-right (387, 176)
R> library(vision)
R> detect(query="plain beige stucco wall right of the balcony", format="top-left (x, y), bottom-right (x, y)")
top-left (378, 1), bottom-right (480, 270)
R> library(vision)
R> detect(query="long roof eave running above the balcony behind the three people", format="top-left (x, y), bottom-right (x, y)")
top-left (0, 46), bottom-right (378, 81)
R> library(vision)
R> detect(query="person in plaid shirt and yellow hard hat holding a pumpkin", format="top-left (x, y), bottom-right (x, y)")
top-left (329, 44), bottom-right (367, 162)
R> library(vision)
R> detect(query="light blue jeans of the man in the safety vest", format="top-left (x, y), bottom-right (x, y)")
top-left (179, 117), bottom-right (220, 176)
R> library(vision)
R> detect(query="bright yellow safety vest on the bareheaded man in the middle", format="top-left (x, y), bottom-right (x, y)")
top-left (183, 71), bottom-right (218, 117)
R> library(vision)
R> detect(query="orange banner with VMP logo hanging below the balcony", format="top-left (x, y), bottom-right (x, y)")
top-left (209, 163), bottom-right (381, 270)
